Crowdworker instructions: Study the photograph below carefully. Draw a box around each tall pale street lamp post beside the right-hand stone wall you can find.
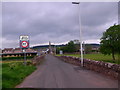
[72,2,83,67]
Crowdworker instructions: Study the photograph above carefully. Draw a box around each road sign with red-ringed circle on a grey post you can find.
[20,35,29,65]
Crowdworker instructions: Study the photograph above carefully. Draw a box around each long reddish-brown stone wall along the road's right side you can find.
[56,56,120,79]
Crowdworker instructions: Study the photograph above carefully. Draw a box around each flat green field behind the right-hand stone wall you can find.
[57,54,120,64]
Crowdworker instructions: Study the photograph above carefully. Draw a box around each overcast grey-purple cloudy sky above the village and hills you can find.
[2,2,118,48]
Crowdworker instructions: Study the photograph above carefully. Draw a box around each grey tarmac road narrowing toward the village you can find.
[17,55,118,88]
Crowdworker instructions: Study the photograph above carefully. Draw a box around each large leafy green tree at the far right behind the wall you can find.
[100,25,120,61]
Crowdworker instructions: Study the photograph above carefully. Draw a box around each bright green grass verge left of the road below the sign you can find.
[2,62,36,88]
